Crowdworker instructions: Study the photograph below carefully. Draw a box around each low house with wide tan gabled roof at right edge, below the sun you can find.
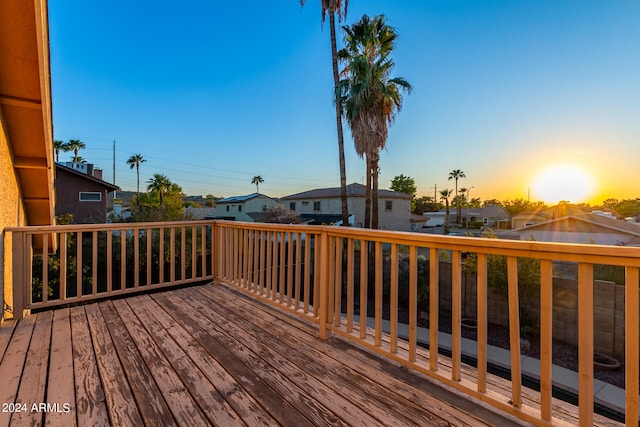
[513,213,640,246]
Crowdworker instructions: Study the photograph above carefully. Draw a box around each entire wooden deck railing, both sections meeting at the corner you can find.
[10,221,640,426]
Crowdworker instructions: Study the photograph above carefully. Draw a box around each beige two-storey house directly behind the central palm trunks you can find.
[280,183,412,231]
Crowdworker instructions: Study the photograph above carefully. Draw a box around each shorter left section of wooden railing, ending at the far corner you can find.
[6,221,215,317]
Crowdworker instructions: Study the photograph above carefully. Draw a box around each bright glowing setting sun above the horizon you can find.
[532,165,595,203]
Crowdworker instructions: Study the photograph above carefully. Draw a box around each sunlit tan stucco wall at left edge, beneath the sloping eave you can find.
[0,106,25,319]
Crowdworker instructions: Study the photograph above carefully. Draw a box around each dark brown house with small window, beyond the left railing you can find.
[56,163,118,224]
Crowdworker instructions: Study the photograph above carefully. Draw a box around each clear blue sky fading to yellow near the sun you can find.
[49,0,640,202]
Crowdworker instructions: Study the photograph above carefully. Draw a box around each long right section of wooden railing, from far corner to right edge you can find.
[216,222,640,426]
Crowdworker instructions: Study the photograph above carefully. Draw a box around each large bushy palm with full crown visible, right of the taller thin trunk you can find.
[338,15,412,228]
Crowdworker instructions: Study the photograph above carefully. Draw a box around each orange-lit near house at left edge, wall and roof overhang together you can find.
[0,0,55,322]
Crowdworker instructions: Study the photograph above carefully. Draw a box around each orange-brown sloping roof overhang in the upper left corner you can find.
[0,0,55,225]
